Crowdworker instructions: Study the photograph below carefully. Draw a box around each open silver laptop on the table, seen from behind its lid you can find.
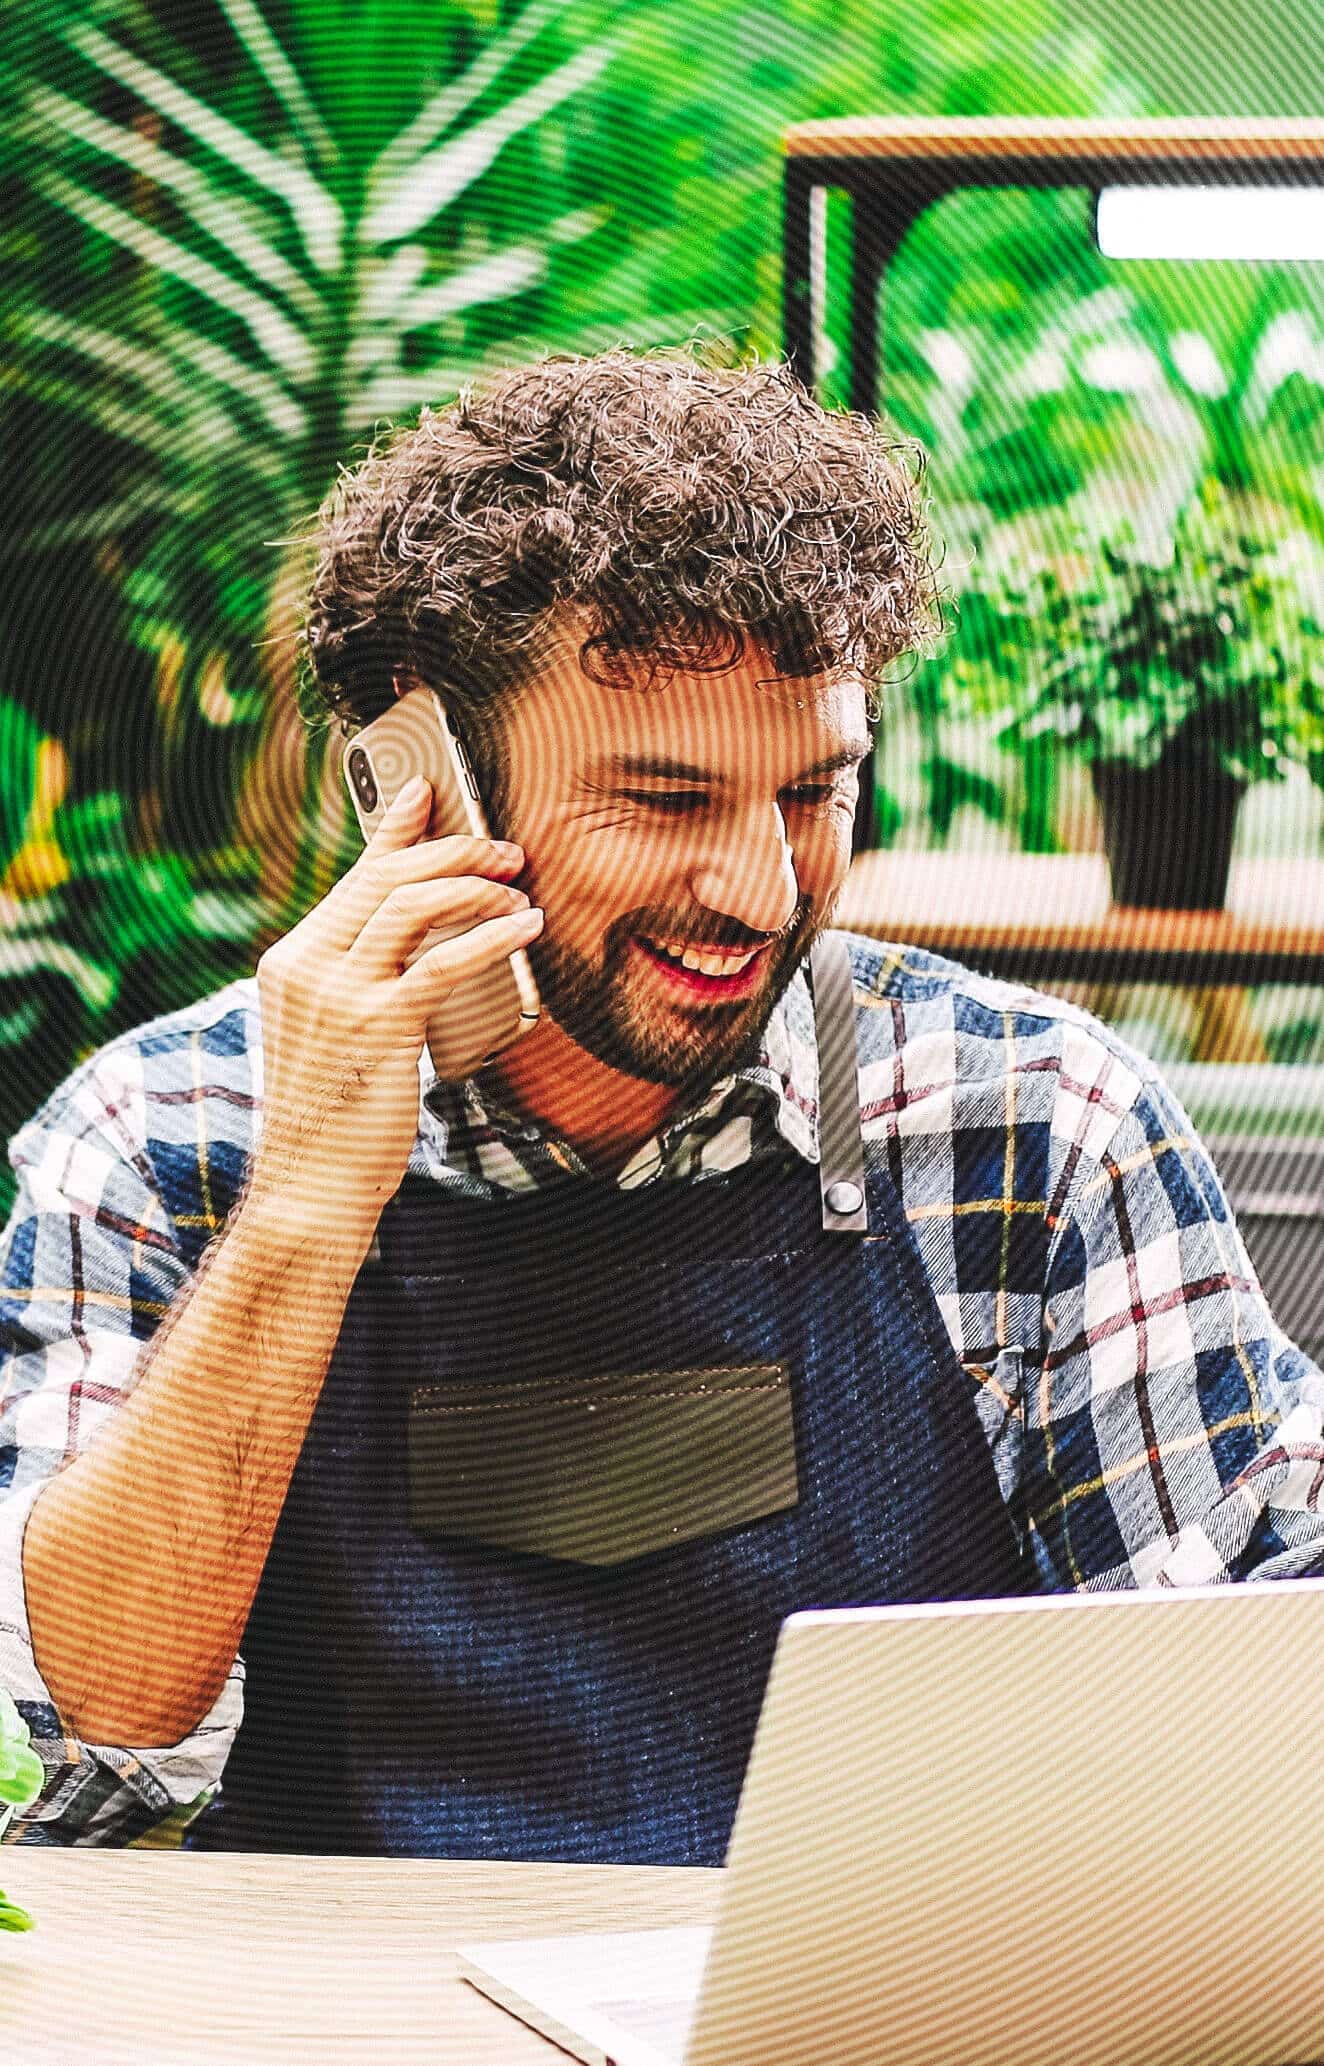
[461,1578,1324,2066]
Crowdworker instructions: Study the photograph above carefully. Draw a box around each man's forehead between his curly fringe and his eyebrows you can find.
[521,638,870,771]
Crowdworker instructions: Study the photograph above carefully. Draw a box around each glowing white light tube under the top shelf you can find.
[1099,186,1324,260]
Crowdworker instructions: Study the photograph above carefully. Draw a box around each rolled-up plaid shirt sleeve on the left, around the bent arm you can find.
[0,1045,244,1845]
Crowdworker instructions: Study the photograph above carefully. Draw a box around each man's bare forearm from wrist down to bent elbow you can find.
[23,1194,372,1748]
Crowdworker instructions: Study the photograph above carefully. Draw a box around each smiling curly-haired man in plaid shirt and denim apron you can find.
[0,353,1324,1864]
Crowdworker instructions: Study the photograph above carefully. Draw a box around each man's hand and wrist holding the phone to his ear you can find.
[248,779,543,1233]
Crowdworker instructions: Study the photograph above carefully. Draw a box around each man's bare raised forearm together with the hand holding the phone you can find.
[20,783,541,1768]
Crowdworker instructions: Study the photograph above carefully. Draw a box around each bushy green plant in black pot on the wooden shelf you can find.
[963,481,1324,911]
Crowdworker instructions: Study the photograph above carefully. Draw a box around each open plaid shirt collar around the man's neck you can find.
[419,967,818,1178]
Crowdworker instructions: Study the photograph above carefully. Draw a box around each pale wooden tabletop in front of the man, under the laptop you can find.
[0,1845,721,2066]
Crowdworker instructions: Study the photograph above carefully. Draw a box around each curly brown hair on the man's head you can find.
[302,349,942,729]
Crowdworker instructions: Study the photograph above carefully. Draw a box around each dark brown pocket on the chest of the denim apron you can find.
[409,1364,799,1566]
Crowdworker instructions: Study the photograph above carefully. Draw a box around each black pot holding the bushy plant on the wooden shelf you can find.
[1091,727,1246,911]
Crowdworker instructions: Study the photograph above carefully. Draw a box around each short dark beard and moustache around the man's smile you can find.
[529,897,830,1097]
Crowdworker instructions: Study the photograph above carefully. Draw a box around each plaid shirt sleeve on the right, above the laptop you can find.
[1024,1076,1324,1589]
